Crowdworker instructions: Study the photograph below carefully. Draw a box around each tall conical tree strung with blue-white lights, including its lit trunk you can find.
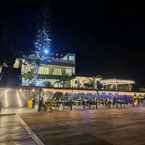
[23,7,51,86]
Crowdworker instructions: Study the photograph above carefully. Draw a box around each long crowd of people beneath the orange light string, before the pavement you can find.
[33,94,145,111]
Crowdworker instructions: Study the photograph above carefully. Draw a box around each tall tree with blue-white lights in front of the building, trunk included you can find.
[24,13,51,86]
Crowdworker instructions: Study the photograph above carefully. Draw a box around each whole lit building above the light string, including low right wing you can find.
[10,53,135,91]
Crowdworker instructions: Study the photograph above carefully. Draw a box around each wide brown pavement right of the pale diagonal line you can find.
[21,108,145,145]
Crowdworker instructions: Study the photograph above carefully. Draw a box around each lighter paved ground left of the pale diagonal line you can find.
[0,115,36,145]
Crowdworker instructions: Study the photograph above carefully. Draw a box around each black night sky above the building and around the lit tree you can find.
[0,0,145,85]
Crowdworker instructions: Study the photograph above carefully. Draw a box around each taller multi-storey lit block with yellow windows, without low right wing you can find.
[14,53,75,88]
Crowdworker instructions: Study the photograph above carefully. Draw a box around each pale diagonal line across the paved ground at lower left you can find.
[16,114,45,145]
